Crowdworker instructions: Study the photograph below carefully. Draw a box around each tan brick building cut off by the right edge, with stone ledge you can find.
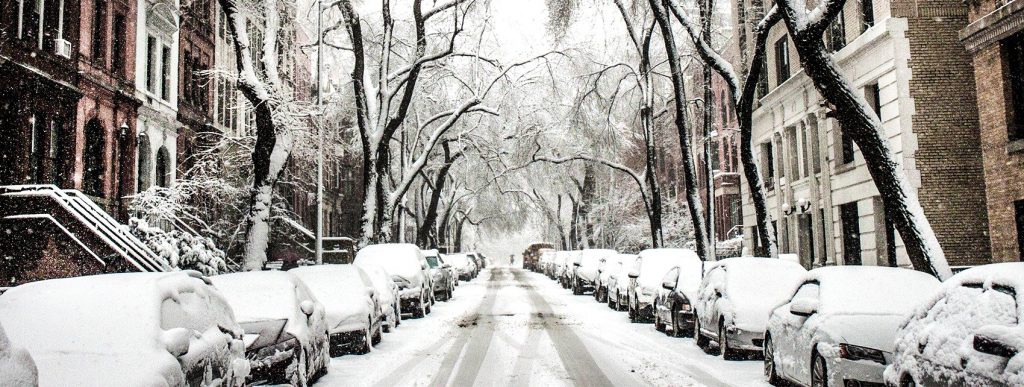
[959,0,1024,262]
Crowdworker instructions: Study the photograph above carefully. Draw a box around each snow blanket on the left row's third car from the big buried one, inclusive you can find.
[288,264,376,332]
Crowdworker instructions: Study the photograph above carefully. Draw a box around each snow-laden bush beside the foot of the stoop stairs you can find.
[129,218,227,275]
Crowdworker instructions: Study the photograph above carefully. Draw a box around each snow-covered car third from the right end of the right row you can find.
[693,257,807,359]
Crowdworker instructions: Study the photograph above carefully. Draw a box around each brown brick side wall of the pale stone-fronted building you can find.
[905,0,990,265]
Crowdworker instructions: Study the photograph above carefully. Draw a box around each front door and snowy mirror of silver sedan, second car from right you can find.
[774,281,821,385]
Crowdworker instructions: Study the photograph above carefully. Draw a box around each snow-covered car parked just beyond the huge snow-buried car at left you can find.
[210,270,331,386]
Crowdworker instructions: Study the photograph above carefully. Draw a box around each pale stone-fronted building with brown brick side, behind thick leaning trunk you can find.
[733,0,990,266]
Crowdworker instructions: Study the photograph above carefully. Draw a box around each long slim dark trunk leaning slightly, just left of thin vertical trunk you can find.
[649,0,709,260]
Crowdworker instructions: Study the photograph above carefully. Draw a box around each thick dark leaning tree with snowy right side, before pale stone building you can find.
[775,0,952,280]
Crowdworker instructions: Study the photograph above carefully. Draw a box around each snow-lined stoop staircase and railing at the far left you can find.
[0,184,172,271]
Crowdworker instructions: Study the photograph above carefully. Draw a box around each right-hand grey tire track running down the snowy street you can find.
[512,269,612,387]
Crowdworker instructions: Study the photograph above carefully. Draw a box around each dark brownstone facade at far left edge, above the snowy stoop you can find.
[0,0,82,187]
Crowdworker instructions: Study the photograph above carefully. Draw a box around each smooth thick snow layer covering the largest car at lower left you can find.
[0,271,241,386]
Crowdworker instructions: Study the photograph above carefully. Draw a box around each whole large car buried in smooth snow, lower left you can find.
[0,271,249,386]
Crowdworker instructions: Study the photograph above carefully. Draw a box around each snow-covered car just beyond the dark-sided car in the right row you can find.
[626,249,699,321]
